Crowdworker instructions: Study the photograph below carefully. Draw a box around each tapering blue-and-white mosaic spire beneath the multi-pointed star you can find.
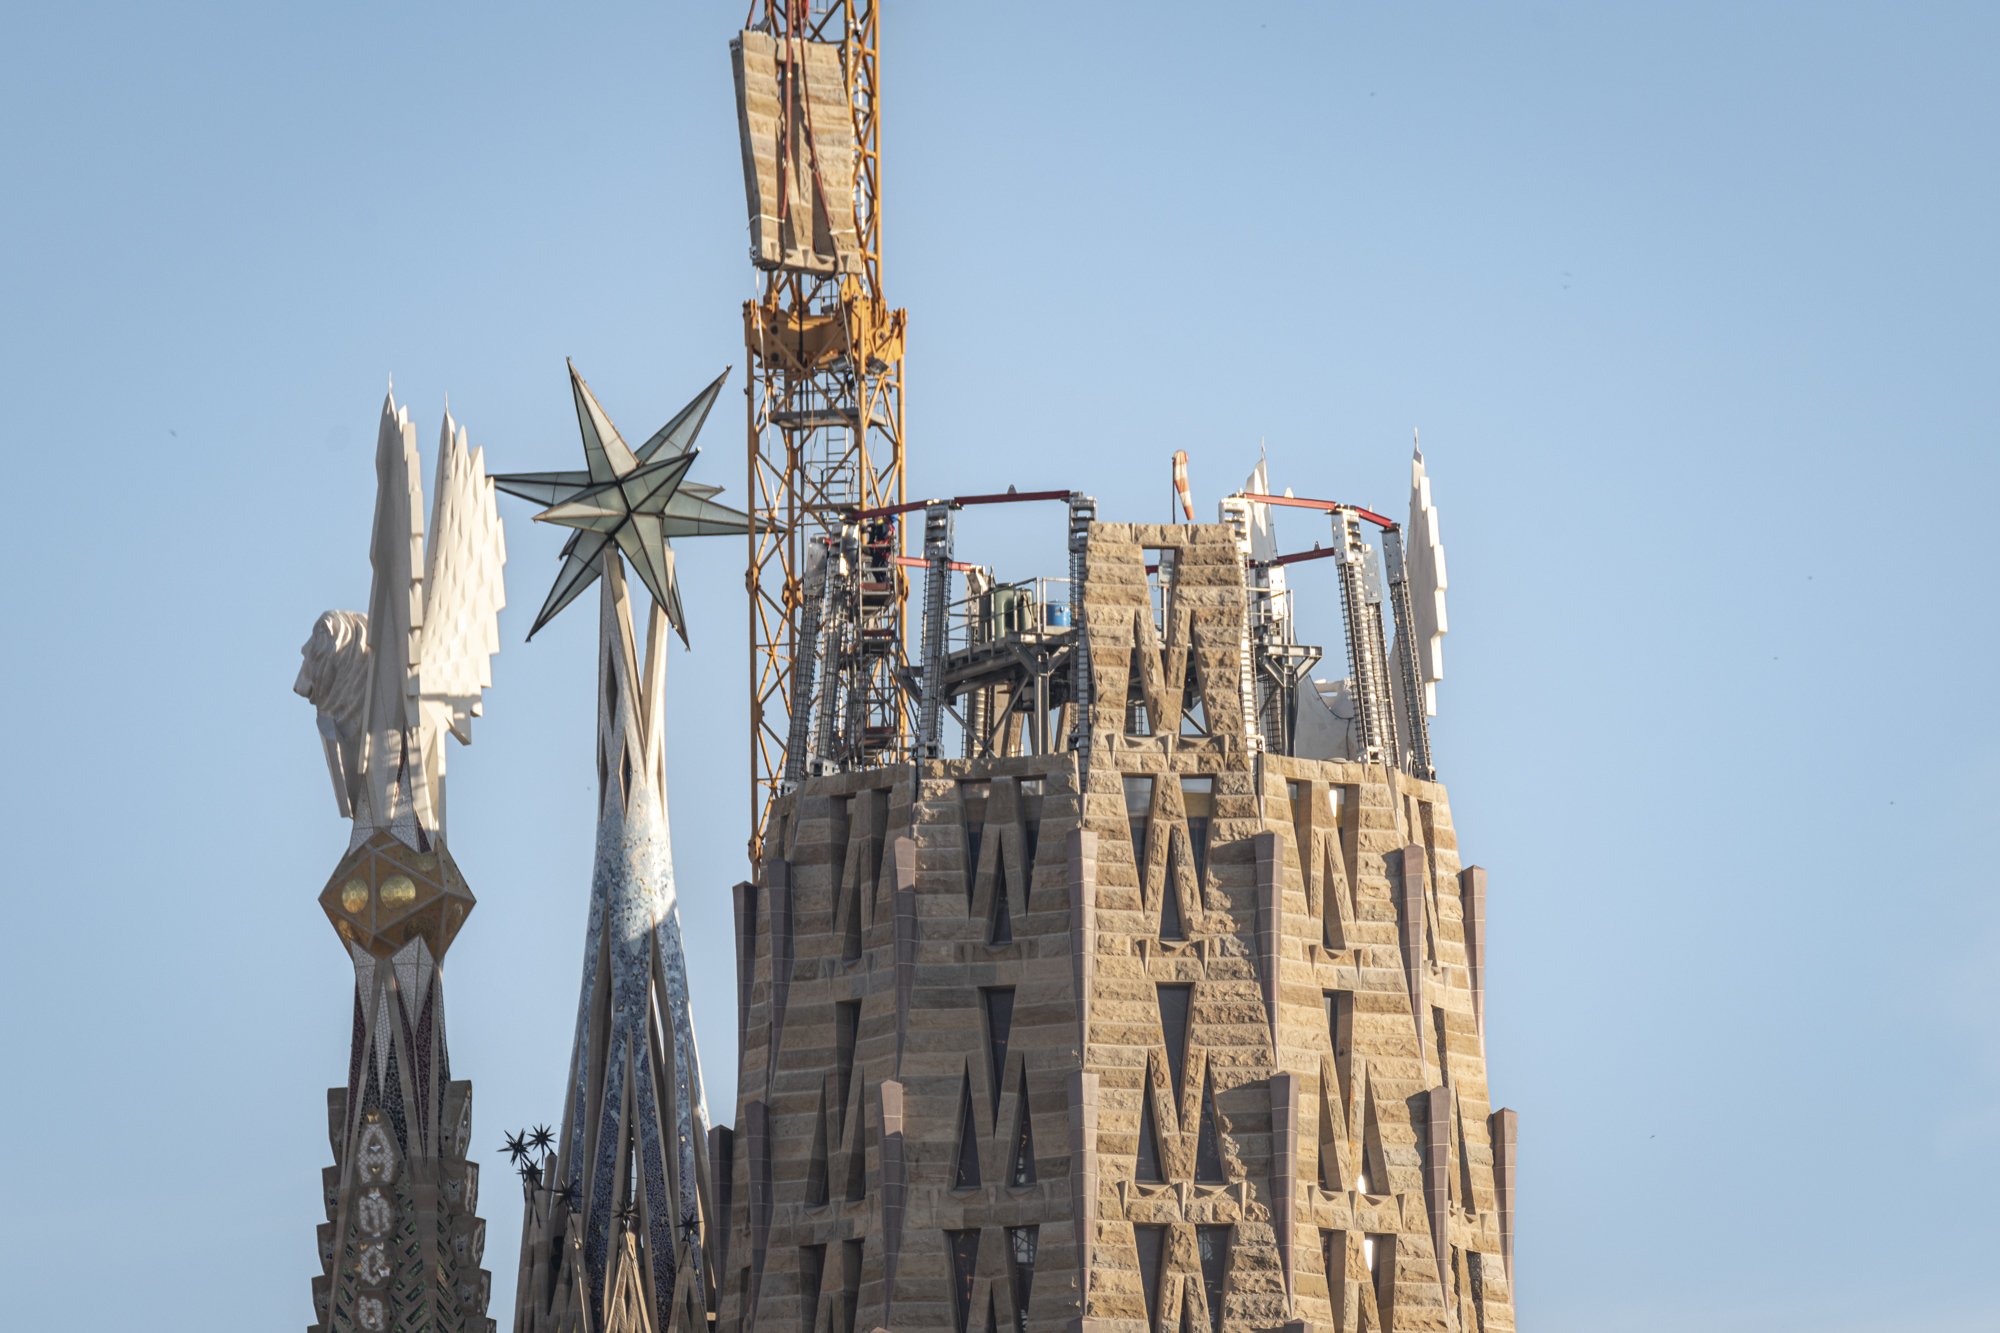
[514,552,710,1333]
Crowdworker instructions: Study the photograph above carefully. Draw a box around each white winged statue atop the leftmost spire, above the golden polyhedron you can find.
[292,390,506,849]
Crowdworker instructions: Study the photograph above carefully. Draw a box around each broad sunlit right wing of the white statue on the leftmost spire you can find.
[420,412,506,740]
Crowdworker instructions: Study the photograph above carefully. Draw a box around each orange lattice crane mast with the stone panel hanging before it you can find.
[732,0,910,863]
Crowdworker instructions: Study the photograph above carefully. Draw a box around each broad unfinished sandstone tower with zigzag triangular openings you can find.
[706,524,1514,1333]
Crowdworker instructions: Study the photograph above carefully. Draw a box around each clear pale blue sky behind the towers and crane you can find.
[0,0,2000,1333]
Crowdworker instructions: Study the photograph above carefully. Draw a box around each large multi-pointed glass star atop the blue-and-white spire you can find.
[492,364,750,642]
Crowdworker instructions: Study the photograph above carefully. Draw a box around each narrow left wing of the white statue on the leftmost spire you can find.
[362,394,424,825]
